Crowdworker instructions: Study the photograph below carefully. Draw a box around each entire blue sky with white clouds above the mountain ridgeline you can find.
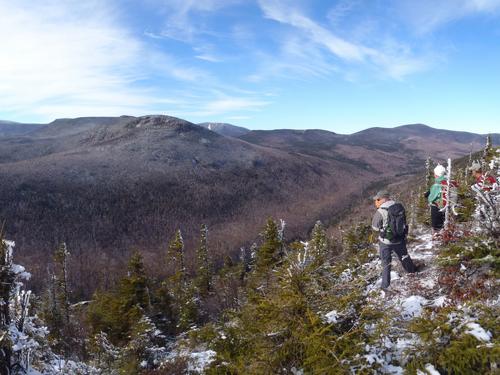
[0,0,500,133]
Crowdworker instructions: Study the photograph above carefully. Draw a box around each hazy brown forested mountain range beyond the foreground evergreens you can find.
[0,115,500,291]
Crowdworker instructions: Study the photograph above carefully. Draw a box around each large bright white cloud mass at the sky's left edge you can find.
[0,0,213,120]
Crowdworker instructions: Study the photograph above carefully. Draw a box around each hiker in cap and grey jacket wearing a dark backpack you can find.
[372,190,416,289]
